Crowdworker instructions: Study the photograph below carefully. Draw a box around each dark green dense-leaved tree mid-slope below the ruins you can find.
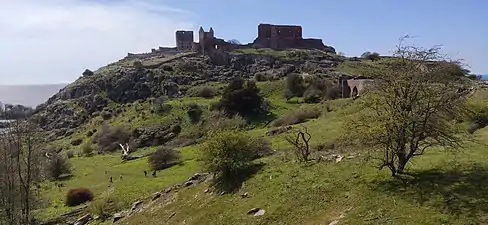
[217,78,263,117]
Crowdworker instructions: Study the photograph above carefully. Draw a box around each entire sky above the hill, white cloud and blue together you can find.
[0,0,488,85]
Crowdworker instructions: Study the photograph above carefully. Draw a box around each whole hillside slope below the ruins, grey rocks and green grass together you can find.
[31,49,488,225]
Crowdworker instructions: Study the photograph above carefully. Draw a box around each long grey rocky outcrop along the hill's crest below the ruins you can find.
[34,49,339,142]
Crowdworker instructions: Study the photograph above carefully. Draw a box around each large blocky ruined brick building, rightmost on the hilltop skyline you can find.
[253,24,335,53]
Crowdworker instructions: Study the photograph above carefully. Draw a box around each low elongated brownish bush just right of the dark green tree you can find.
[270,107,322,127]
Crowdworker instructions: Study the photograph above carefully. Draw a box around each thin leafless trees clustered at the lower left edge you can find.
[0,120,43,225]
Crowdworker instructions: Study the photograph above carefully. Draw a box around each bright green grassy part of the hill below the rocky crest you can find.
[30,50,488,225]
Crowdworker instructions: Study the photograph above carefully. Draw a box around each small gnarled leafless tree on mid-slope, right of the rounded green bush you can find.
[285,126,312,162]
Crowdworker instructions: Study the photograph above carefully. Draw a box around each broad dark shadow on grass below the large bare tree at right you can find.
[373,165,488,220]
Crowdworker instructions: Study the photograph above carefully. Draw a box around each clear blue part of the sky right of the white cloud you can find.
[170,0,488,73]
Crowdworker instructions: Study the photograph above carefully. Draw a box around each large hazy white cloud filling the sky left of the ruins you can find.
[0,0,195,84]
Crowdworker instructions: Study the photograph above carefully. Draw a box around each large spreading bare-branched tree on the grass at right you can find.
[345,36,469,176]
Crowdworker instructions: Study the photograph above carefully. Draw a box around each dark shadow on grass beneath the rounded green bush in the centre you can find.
[213,163,265,193]
